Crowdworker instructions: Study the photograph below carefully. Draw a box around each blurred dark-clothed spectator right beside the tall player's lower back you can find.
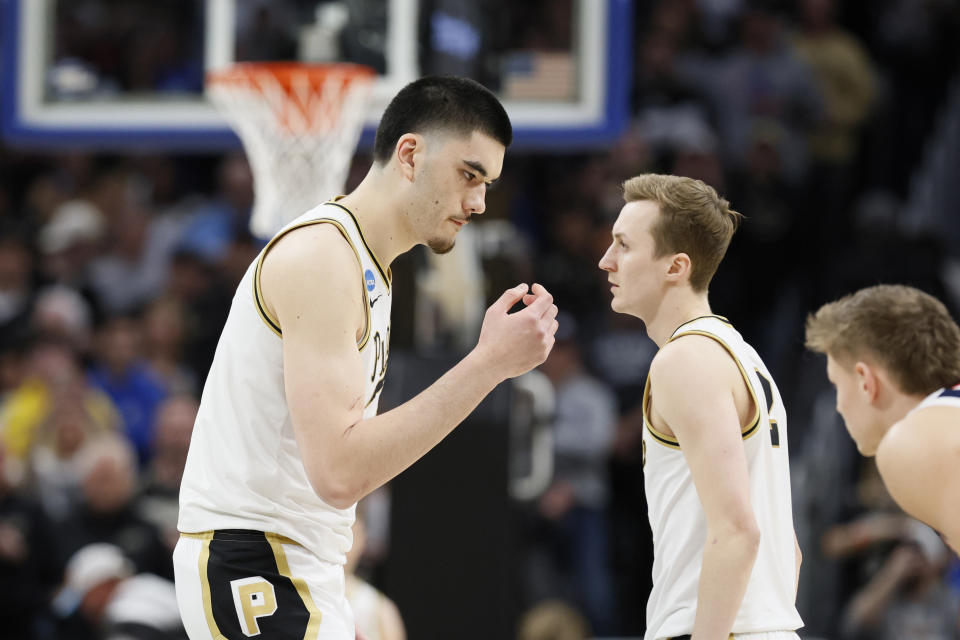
[138,394,199,554]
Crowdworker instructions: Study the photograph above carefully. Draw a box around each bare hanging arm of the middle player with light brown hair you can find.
[650,336,760,640]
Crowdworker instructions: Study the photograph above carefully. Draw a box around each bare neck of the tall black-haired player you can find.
[340,166,416,267]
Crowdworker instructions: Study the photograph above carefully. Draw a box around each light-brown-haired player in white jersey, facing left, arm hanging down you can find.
[600,174,802,640]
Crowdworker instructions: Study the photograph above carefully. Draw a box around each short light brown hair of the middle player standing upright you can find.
[623,173,743,292]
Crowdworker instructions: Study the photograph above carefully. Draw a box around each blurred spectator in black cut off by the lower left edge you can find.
[0,444,63,640]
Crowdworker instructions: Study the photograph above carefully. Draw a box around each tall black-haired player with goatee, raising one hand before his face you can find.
[174,77,557,640]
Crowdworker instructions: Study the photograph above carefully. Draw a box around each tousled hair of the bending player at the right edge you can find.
[807,285,960,395]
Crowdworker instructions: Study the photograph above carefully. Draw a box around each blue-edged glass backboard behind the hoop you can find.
[0,0,632,151]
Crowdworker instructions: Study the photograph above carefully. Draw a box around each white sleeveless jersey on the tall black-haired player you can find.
[178,201,391,564]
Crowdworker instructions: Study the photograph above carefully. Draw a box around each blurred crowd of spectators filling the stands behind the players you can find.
[0,0,960,640]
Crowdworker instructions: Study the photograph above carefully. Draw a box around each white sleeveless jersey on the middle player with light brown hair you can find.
[643,316,803,640]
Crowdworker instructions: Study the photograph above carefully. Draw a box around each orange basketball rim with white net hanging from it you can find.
[207,62,375,238]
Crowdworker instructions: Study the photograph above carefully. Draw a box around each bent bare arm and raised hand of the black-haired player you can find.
[261,224,557,508]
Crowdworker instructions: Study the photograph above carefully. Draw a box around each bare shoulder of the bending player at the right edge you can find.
[877,407,960,553]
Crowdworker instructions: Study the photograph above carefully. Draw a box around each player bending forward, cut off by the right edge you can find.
[807,285,960,552]
